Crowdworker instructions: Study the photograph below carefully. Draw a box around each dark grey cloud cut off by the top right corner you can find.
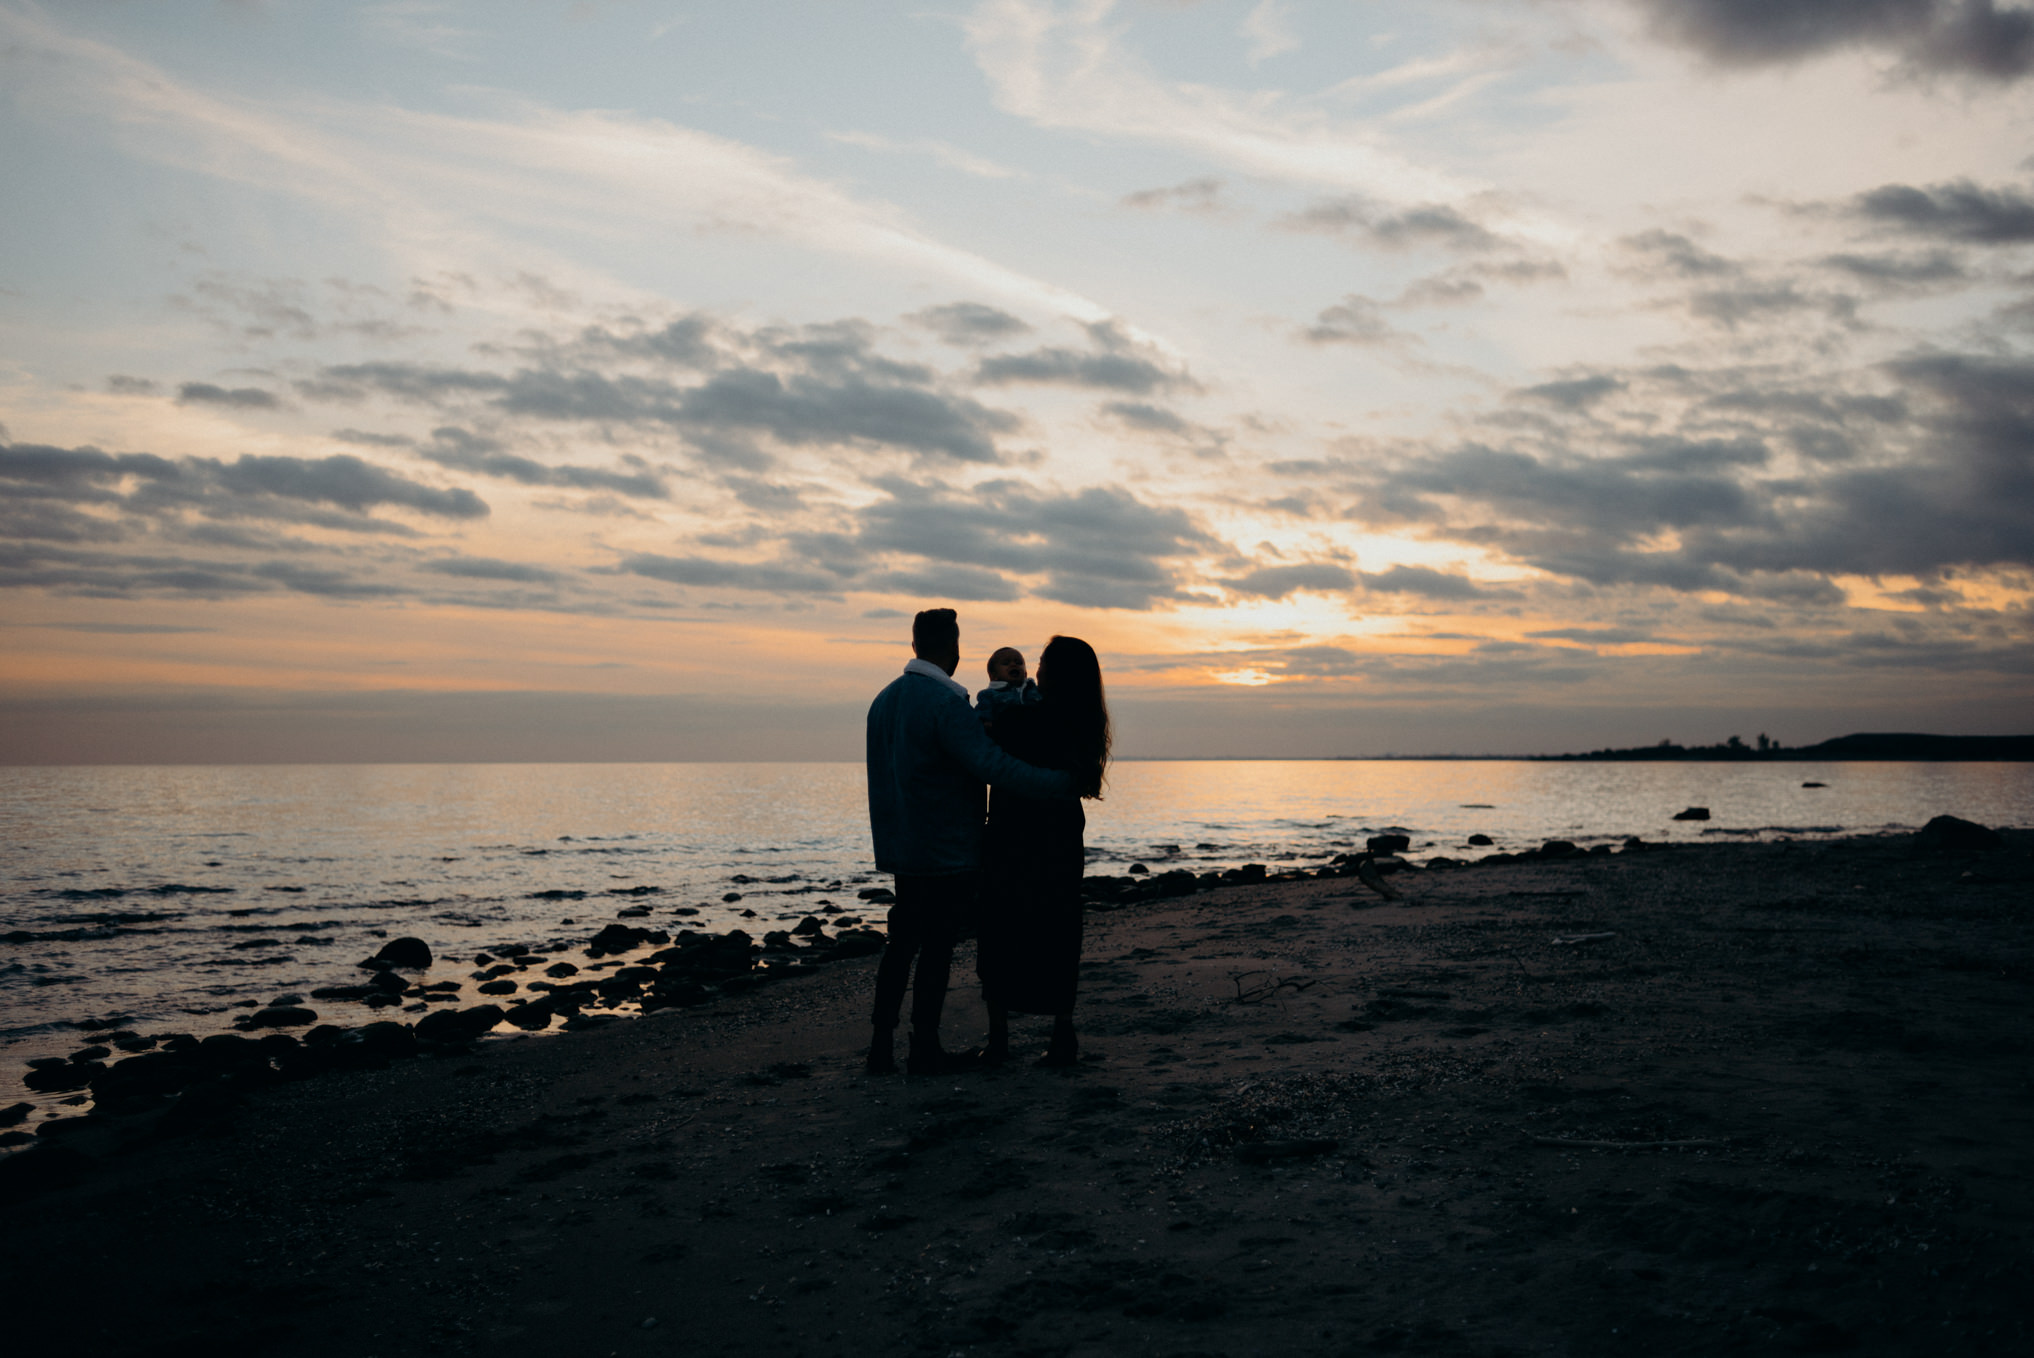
[1633,0,2034,81]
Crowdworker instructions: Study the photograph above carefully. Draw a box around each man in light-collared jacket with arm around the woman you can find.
[869,608,1076,1075]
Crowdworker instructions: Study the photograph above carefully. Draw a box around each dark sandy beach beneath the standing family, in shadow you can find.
[0,834,2034,1358]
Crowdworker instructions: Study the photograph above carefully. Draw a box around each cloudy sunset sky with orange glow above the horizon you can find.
[0,0,2034,762]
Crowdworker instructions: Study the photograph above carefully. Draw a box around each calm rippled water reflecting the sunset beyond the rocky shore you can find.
[0,760,2034,1102]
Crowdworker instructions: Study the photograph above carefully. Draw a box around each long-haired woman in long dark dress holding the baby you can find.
[974,636,1109,1065]
